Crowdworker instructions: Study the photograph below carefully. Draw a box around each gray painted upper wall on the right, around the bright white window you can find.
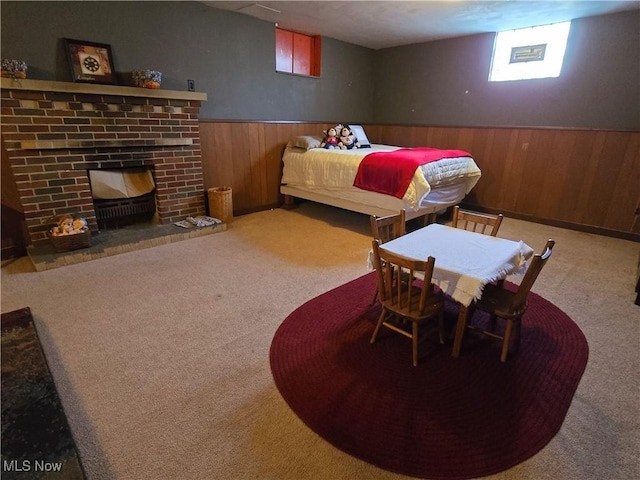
[374,11,640,130]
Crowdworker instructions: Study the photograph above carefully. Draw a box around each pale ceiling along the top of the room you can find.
[201,0,640,50]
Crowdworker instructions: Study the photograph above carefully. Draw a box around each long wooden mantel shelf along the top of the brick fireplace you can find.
[1,78,207,101]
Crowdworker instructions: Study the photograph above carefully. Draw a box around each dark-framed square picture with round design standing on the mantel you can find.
[64,38,116,84]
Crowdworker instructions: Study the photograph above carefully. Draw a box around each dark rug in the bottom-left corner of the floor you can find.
[1,308,85,480]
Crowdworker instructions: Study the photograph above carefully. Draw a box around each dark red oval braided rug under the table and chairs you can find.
[270,273,588,479]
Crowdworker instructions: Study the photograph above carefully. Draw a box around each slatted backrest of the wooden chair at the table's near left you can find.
[372,240,436,316]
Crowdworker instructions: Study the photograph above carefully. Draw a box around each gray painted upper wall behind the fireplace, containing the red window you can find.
[1,1,375,123]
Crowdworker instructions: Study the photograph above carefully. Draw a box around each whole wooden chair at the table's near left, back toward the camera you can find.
[371,240,444,367]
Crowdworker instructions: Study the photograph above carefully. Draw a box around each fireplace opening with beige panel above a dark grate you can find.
[89,168,156,229]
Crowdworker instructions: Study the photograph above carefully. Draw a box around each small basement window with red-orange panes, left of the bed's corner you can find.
[276,28,321,77]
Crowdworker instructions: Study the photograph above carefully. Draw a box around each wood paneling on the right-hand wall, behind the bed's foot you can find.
[368,126,640,236]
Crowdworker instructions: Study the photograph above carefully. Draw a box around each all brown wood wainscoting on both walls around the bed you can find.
[200,120,640,240]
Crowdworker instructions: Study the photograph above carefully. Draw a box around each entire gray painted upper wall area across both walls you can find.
[0,0,640,130]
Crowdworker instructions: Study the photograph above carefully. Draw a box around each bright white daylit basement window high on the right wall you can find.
[489,22,571,82]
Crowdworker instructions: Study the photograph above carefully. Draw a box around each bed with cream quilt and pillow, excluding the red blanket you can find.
[280,130,481,219]
